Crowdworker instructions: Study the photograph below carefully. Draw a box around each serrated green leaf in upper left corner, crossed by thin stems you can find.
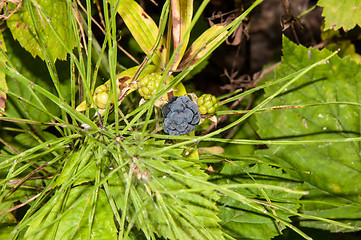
[6,0,75,62]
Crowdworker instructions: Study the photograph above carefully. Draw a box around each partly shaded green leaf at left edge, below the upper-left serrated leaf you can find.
[0,31,70,122]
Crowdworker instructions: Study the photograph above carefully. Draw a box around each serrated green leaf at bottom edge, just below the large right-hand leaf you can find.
[215,161,302,239]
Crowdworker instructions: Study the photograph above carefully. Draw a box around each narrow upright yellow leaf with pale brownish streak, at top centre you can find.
[171,0,193,71]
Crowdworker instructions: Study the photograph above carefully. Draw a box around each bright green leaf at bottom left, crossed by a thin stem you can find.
[25,186,117,240]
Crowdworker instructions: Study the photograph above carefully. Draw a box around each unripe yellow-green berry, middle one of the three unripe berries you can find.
[138,73,162,100]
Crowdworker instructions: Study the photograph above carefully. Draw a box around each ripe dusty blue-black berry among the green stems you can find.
[162,96,200,136]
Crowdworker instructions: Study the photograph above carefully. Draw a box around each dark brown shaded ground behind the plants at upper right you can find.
[194,0,322,95]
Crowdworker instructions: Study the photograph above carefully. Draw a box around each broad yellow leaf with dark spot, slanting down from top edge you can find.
[110,0,166,66]
